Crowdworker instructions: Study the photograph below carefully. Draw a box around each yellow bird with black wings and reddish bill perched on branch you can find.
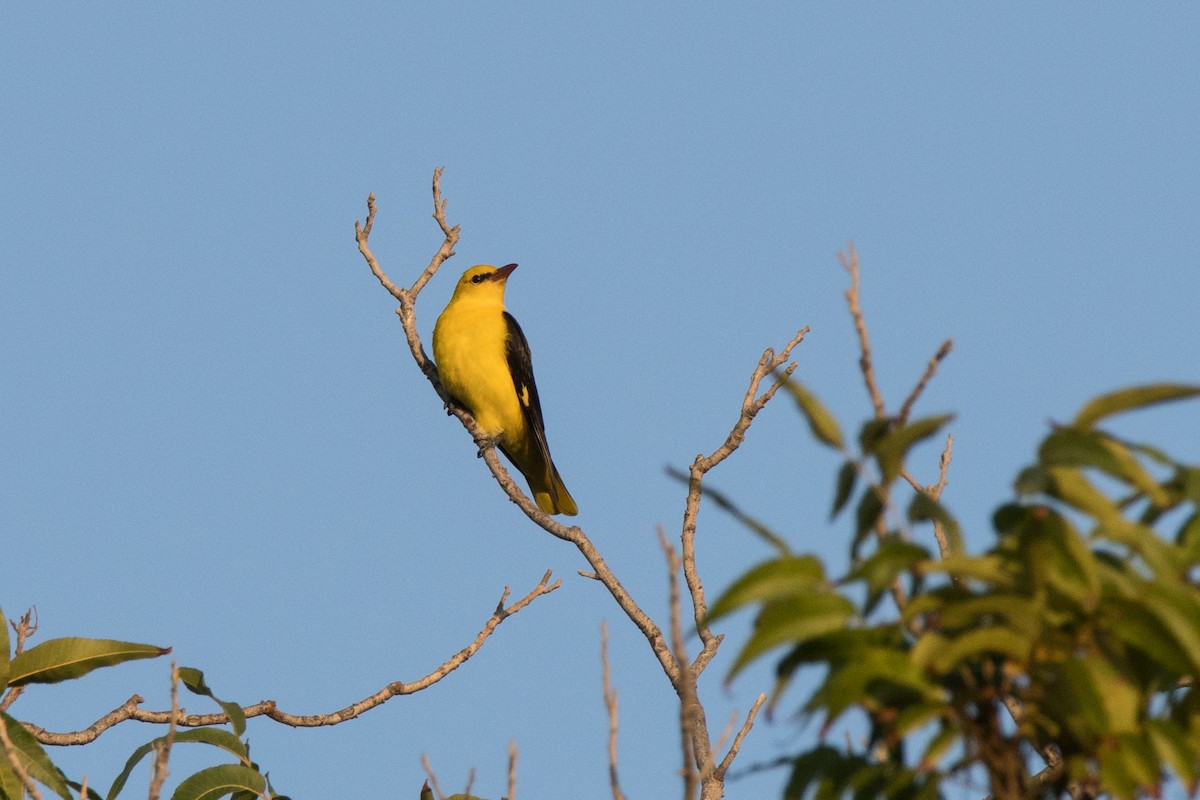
[433,264,578,516]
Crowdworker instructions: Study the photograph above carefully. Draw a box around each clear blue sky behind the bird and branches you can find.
[0,2,1200,799]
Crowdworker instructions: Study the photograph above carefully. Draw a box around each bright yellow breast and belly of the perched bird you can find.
[433,292,526,440]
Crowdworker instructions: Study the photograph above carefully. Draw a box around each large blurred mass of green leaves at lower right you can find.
[713,385,1200,800]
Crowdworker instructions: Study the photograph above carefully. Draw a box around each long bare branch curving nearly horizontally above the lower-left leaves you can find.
[24,570,563,745]
